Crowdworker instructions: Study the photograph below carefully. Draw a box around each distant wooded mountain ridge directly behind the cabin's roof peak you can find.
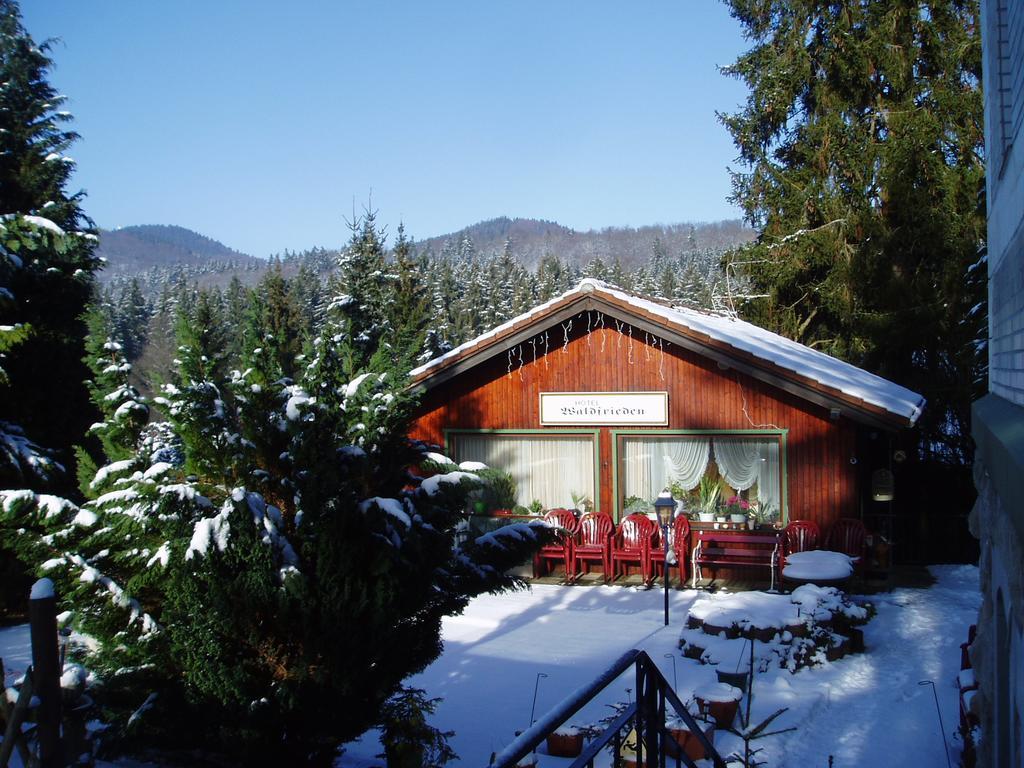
[416,216,755,267]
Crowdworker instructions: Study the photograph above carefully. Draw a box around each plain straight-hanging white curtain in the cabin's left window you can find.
[453,434,596,509]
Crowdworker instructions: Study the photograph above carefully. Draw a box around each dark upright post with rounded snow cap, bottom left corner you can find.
[29,579,61,768]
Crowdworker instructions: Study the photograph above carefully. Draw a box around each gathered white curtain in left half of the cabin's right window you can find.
[623,437,711,502]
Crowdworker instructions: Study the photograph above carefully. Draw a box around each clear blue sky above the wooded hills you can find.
[22,0,745,256]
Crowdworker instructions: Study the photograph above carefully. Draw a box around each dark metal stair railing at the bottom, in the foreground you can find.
[489,648,726,768]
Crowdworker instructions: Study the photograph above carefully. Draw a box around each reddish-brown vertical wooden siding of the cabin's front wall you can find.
[412,316,857,526]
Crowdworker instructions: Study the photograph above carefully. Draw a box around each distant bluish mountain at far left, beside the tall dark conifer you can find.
[97,224,266,282]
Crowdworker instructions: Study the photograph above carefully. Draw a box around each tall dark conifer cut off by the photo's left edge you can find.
[0,0,98,492]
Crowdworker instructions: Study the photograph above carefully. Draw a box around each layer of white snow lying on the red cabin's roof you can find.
[410,278,925,426]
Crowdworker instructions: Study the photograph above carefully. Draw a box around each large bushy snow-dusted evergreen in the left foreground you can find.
[0,293,548,764]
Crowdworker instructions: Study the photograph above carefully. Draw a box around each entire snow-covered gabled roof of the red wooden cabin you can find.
[411,279,925,425]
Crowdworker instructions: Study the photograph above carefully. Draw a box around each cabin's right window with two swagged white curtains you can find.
[618,432,785,519]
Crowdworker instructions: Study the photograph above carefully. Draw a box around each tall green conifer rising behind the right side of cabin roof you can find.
[722,0,985,463]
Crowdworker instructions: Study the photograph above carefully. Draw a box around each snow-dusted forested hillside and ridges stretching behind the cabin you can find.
[101,213,752,397]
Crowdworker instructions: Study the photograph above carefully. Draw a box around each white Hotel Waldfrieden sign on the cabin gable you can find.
[541,392,669,427]
